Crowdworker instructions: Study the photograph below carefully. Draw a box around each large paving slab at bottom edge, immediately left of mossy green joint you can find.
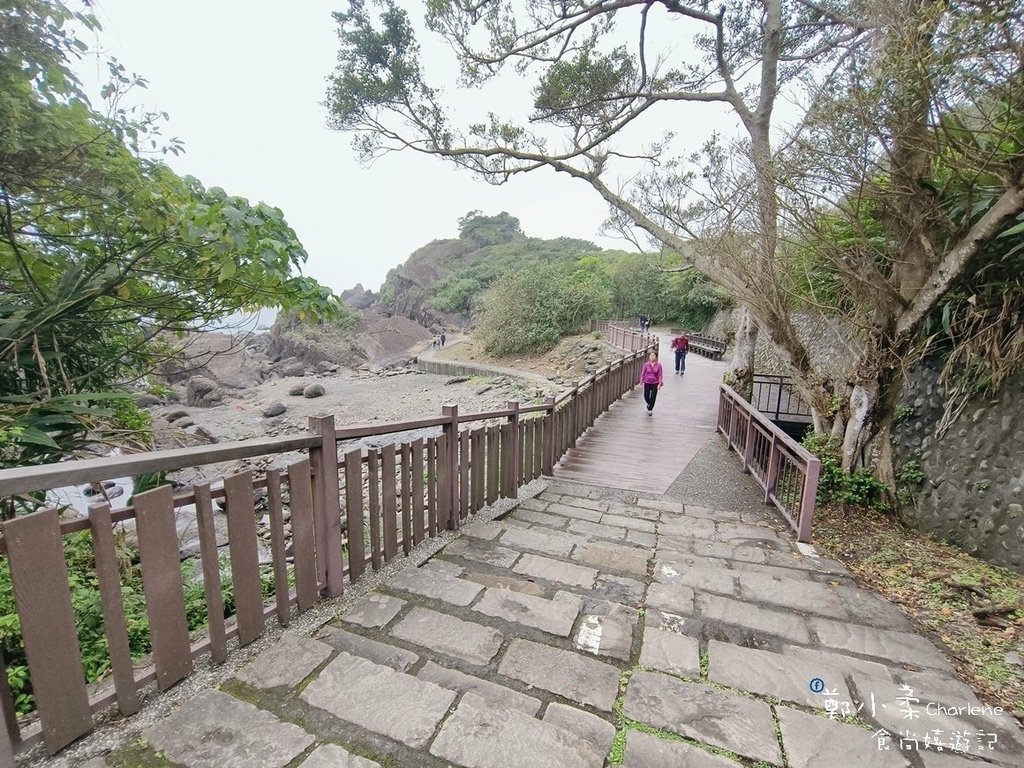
[430,693,604,768]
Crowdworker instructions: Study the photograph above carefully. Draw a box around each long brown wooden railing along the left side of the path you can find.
[0,348,648,763]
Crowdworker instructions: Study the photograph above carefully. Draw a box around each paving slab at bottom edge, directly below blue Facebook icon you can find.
[775,707,910,768]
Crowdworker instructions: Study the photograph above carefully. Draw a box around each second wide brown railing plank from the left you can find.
[134,485,193,690]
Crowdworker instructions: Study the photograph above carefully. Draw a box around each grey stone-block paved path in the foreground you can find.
[105,484,1024,768]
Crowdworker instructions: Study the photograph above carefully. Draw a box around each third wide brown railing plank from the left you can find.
[224,472,265,646]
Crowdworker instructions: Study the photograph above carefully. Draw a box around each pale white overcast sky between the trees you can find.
[78,0,734,291]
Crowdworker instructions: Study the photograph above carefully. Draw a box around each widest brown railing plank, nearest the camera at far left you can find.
[3,509,91,755]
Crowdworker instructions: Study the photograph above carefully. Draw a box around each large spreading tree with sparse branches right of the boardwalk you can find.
[328,0,1024,501]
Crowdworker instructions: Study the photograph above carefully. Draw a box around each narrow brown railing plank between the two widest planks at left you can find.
[89,504,138,717]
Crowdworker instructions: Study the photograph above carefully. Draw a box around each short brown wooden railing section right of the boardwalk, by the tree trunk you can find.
[718,384,821,542]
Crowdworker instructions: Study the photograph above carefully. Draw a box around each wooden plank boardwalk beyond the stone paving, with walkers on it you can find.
[555,334,727,494]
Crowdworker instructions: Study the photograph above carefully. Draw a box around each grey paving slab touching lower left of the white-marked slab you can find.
[498,639,618,712]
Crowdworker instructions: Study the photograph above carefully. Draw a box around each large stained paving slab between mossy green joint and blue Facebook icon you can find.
[623,671,782,765]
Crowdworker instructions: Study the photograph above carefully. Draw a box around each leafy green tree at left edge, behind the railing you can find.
[0,0,340,475]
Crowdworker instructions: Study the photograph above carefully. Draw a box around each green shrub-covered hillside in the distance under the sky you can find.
[381,211,728,354]
